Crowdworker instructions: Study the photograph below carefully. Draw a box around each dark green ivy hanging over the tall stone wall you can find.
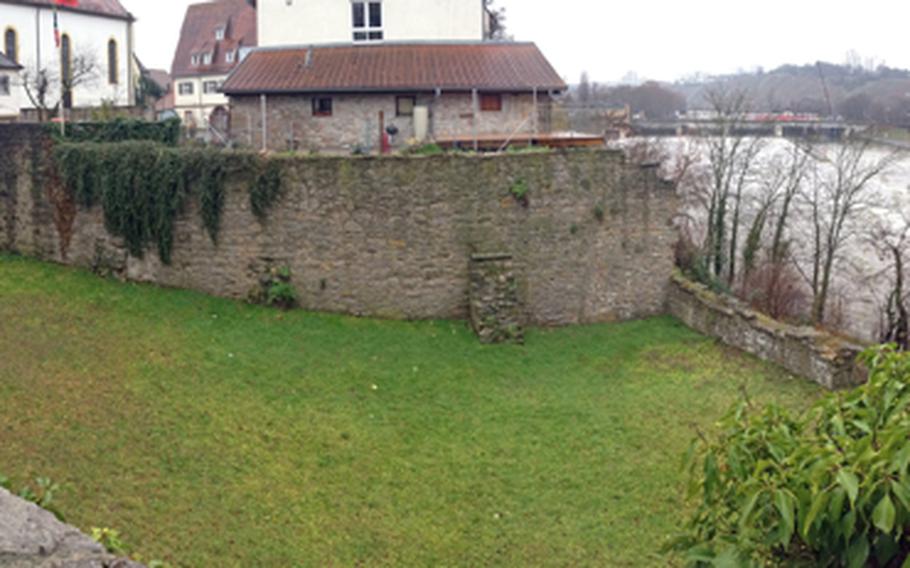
[53,141,284,264]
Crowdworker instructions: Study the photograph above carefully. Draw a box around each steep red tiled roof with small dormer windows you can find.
[171,0,256,77]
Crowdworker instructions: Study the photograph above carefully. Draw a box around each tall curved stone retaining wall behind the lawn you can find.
[0,126,677,325]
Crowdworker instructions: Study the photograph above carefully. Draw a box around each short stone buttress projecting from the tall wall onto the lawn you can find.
[469,254,524,343]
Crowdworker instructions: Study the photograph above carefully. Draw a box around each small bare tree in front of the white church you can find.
[20,48,100,122]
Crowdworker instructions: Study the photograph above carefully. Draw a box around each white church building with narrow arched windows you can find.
[0,0,135,118]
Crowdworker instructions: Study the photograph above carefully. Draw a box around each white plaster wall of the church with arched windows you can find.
[0,2,133,112]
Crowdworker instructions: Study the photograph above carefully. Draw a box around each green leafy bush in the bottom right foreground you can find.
[674,347,910,568]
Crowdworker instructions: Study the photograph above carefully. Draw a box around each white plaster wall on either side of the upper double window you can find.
[257,0,484,47]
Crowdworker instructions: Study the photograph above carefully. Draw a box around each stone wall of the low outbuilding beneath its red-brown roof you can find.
[231,93,550,153]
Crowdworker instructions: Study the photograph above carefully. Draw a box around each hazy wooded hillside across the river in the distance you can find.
[668,63,910,126]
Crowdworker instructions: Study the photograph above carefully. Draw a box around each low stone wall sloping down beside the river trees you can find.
[668,273,866,389]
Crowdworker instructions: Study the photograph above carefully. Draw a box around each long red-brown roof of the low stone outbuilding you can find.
[223,42,566,95]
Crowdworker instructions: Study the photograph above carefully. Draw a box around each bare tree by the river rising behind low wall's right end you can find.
[803,140,899,324]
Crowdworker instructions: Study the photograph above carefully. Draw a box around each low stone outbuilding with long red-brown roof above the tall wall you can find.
[223,42,566,151]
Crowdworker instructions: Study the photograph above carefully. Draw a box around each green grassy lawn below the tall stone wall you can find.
[0,256,818,566]
